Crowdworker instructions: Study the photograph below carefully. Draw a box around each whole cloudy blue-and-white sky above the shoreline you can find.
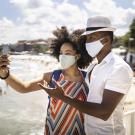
[0,0,135,44]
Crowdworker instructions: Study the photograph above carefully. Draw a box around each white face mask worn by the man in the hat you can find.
[85,38,104,57]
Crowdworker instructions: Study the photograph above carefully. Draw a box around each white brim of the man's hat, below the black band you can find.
[81,27,116,36]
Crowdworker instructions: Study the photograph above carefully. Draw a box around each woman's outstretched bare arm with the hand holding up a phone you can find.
[0,56,52,93]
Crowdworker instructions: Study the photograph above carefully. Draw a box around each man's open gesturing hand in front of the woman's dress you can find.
[38,80,65,99]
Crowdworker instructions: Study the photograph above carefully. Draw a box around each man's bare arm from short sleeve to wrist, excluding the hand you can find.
[61,90,124,120]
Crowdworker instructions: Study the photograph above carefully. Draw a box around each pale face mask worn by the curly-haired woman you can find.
[59,54,76,69]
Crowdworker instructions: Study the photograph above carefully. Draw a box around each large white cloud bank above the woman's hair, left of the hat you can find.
[1,0,87,42]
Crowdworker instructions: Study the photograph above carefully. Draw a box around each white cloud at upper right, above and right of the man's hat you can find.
[84,0,135,35]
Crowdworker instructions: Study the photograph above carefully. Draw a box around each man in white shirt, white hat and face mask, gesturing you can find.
[39,16,133,135]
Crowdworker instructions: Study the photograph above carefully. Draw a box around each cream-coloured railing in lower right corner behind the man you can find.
[124,109,135,135]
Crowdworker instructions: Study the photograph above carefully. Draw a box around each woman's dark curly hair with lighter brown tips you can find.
[50,26,92,68]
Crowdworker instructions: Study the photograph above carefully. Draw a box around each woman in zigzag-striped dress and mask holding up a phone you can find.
[0,27,90,135]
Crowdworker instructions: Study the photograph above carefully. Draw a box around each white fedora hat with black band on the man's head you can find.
[82,16,116,35]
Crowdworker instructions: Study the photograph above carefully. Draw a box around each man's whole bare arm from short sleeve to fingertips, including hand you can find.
[39,83,124,120]
